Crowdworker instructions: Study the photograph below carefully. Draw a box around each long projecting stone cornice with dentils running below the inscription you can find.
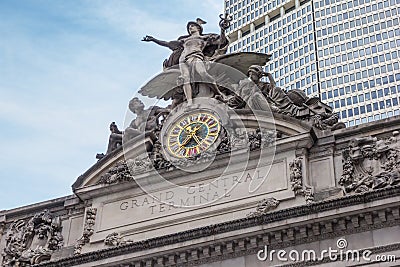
[36,186,400,267]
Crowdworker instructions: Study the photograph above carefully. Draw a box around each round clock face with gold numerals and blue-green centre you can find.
[167,112,221,158]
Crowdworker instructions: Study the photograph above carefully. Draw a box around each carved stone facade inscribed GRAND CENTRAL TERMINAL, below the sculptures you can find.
[0,114,400,267]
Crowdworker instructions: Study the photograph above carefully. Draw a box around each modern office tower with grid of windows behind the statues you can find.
[225,0,400,126]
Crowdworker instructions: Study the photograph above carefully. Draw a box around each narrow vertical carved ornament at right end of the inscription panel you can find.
[289,157,314,203]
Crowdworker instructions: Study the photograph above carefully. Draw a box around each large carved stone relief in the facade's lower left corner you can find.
[2,210,63,267]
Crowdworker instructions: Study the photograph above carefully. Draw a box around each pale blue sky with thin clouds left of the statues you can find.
[0,0,223,210]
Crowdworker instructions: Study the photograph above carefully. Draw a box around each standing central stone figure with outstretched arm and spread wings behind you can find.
[139,15,270,106]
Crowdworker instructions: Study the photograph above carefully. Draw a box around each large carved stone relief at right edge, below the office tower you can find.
[339,131,400,193]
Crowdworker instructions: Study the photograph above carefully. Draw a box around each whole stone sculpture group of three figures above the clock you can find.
[99,15,344,158]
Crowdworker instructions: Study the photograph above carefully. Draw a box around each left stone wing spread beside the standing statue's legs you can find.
[139,68,181,100]
